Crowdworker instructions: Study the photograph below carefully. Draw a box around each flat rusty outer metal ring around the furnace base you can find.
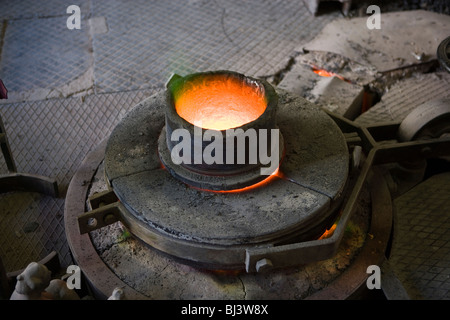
[64,140,392,300]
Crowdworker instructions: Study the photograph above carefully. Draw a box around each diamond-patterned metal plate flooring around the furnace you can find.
[0,0,450,299]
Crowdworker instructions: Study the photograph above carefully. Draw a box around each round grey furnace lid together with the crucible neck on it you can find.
[76,71,349,270]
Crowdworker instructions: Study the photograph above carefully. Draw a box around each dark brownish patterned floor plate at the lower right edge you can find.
[390,173,450,300]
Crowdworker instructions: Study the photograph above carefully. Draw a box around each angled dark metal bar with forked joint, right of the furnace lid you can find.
[245,110,450,272]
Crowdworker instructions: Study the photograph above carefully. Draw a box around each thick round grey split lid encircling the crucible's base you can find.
[105,91,349,268]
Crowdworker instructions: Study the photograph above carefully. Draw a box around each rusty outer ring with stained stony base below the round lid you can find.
[64,149,392,300]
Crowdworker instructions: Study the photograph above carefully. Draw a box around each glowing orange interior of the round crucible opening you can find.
[175,77,267,130]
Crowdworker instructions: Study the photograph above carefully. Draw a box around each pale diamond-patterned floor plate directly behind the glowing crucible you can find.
[92,1,337,92]
